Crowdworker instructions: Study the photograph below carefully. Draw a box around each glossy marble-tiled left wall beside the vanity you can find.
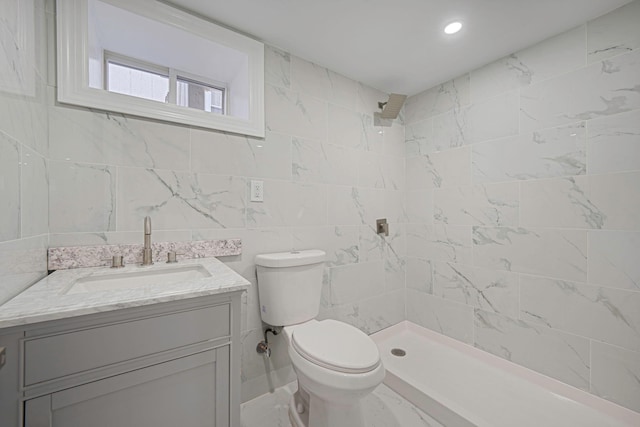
[0,0,49,304]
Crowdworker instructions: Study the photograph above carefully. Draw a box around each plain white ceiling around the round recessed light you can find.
[170,0,630,95]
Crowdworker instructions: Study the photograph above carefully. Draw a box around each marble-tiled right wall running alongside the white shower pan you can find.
[405,1,640,411]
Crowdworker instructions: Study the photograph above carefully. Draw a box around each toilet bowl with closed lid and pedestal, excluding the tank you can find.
[284,320,385,427]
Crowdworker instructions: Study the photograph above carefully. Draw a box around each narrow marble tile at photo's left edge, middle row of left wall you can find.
[0,132,20,241]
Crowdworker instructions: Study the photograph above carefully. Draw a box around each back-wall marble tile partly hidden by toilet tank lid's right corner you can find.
[291,226,360,267]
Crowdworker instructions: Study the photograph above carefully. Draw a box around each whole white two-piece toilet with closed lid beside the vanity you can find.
[255,250,385,427]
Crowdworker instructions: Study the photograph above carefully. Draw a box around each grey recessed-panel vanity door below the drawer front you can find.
[25,346,229,427]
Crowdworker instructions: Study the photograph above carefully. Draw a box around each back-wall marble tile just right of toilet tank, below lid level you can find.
[330,261,385,305]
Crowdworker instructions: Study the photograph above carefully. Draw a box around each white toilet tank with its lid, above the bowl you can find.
[255,249,325,326]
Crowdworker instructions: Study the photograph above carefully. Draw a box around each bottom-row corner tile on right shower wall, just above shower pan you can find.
[407,289,473,344]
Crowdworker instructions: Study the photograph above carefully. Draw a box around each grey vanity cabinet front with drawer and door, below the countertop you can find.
[0,292,241,427]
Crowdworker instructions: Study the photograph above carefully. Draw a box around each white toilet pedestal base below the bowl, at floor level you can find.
[289,389,365,427]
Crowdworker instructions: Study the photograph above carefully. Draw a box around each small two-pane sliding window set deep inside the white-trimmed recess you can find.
[104,52,227,114]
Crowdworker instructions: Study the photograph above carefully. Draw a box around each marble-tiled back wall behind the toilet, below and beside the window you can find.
[48,5,405,400]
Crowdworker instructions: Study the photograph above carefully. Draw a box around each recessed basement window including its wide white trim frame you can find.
[56,0,265,137]
